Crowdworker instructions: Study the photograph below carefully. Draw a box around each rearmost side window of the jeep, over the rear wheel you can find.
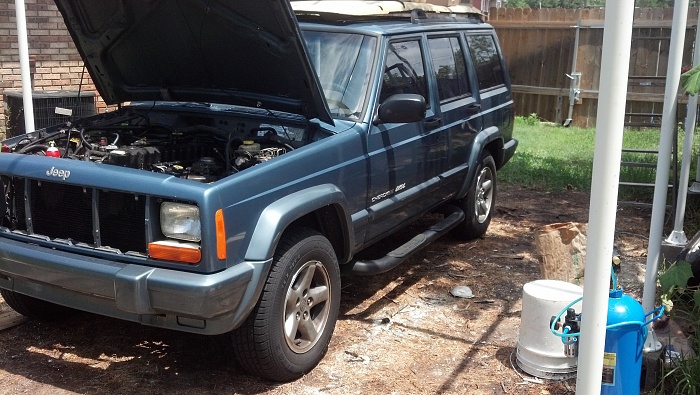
[466,35,505,90]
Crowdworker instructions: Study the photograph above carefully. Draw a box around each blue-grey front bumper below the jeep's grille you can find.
[0,238,271,335]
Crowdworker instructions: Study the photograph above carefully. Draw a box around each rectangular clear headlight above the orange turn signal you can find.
[160,202,202,242]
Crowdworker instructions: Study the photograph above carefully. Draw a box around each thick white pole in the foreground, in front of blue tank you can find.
[576,0,634,395]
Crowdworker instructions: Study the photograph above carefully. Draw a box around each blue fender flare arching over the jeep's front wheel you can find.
[245,184,354,263]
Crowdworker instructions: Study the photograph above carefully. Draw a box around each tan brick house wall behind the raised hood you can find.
[0,0,106,133]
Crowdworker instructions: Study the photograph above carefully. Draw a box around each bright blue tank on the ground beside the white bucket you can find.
[600,290,648,395]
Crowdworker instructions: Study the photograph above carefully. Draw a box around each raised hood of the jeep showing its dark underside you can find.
[56,0,333,123]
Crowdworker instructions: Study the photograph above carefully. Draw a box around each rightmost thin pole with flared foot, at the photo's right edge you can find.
[666,9,700,245]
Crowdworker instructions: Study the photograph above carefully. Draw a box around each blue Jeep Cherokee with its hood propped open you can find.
[0,0,517,381]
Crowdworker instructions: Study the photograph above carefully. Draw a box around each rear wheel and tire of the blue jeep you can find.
[452,152,497,240]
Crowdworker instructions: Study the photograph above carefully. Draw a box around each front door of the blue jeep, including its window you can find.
[367,37,447,240]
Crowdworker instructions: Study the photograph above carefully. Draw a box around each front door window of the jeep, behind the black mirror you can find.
[379,40,428,102]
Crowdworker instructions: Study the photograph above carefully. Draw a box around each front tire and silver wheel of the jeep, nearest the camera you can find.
[231,228,340,382]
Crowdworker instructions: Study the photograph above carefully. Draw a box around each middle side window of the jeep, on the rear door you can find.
[428,37,470,102]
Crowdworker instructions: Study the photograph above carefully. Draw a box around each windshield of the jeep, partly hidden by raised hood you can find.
[304,31,377,120]
